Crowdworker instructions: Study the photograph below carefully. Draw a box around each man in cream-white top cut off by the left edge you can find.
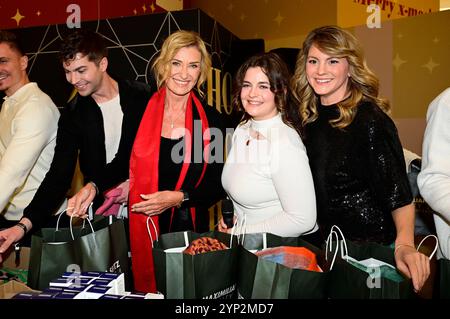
[0,31,59,235]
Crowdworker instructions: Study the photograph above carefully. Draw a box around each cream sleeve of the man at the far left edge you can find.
[0,101,57,211]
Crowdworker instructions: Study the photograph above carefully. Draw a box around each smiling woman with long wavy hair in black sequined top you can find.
[292,26,430,290]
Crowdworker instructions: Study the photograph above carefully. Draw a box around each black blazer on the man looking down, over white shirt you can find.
[23,80,151,229]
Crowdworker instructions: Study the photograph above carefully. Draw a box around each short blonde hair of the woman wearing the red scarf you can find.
[152,30,211,96]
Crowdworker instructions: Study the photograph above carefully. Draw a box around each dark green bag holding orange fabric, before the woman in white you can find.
[237,233,328,299]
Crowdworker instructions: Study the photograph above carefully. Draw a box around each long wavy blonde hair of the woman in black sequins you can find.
[292,26,390,129]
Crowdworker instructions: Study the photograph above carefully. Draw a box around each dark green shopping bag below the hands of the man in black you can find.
[28,217,129,290]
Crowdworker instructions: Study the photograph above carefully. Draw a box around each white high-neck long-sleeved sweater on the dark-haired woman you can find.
[222,115,317,237]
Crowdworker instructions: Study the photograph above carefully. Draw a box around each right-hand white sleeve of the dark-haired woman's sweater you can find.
[246,131,317,237]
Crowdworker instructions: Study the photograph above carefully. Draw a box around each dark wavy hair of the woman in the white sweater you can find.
[232,52,302,136]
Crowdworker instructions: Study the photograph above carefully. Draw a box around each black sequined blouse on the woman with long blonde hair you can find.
[305,102,413,244]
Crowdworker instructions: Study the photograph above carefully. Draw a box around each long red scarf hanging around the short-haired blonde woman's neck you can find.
[128,87,211,292]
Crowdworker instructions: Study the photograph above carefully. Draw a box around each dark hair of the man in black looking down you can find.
[59,29,108,64]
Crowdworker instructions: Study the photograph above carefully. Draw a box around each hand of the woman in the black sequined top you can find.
[394,245,430,292]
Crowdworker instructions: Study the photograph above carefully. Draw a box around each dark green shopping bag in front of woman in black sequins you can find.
[328,240,413,299]
